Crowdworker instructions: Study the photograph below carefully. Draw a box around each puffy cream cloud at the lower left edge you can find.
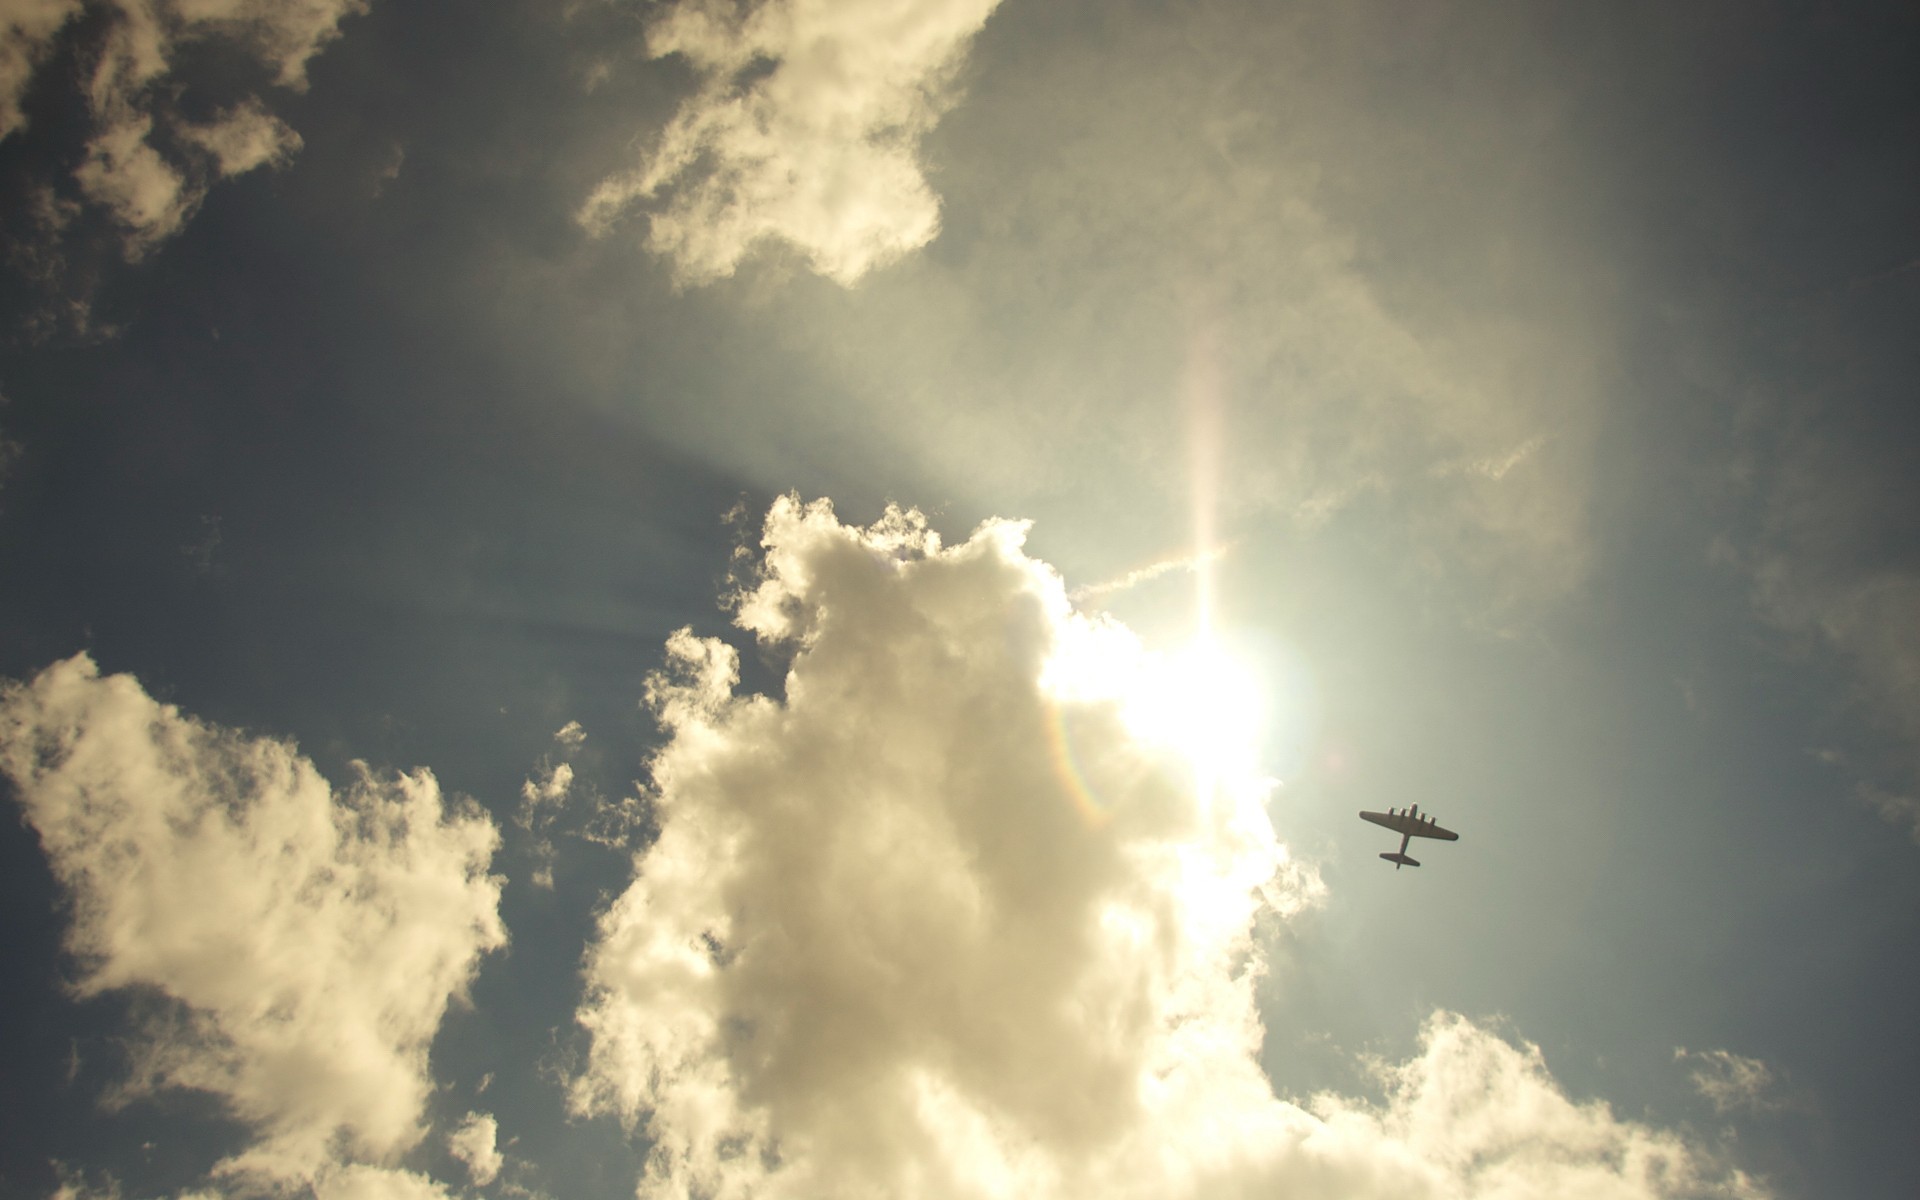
[0,655,505,1196]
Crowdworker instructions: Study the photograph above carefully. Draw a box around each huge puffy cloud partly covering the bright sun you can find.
[572,497,1764,1200]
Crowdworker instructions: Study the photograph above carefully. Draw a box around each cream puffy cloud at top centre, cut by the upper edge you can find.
[580,0,998,286]
